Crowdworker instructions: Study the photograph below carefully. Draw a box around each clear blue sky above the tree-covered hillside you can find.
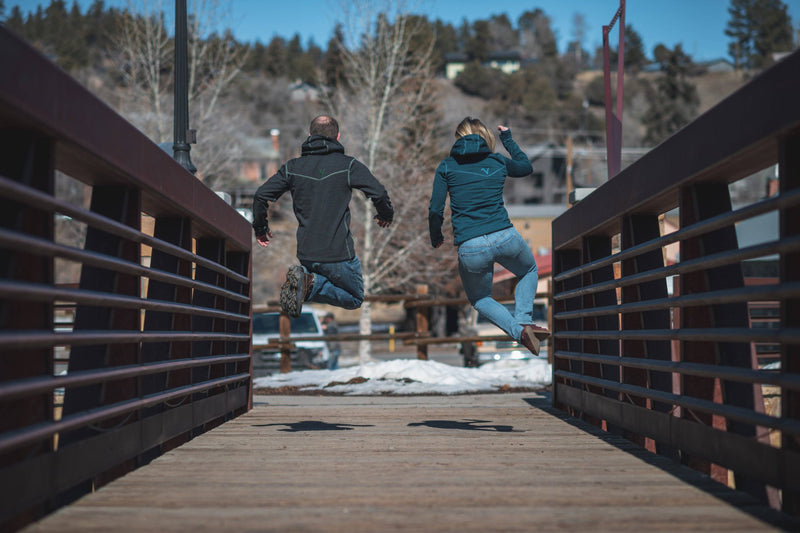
[6,0,800,61]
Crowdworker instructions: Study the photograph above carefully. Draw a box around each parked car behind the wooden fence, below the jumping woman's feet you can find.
[461,299,548,367]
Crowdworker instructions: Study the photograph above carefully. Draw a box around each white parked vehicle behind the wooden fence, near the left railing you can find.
[253,308,331,377]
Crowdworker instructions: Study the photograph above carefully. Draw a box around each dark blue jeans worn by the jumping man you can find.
[300,257,364,309]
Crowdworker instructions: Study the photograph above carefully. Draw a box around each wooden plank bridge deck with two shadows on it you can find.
[26,393,791,533]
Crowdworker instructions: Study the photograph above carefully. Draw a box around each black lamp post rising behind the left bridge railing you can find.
[172,0,197,174]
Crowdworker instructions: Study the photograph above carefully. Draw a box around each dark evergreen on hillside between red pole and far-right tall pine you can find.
[642,45,700,144]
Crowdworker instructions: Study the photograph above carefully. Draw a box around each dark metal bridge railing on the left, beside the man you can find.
[0,27,251,529]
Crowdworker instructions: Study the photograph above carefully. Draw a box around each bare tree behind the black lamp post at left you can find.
[113,0,246,188]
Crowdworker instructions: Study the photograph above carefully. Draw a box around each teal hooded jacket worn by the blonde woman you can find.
[428,130,533,246]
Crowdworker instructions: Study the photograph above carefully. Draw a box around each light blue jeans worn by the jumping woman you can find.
[458,228,539,340]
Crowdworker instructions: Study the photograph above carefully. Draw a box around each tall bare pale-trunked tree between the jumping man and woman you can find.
[328,0,454,363]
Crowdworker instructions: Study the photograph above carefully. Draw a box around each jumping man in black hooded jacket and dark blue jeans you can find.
[253,115,394,318]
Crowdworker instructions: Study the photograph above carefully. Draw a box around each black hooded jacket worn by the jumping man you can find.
[253,135,394,263]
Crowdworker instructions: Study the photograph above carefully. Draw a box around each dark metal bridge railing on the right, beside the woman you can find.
[551,52,800,515]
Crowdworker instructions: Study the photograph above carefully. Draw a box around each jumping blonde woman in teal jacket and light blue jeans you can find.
[428,117,550,355]
